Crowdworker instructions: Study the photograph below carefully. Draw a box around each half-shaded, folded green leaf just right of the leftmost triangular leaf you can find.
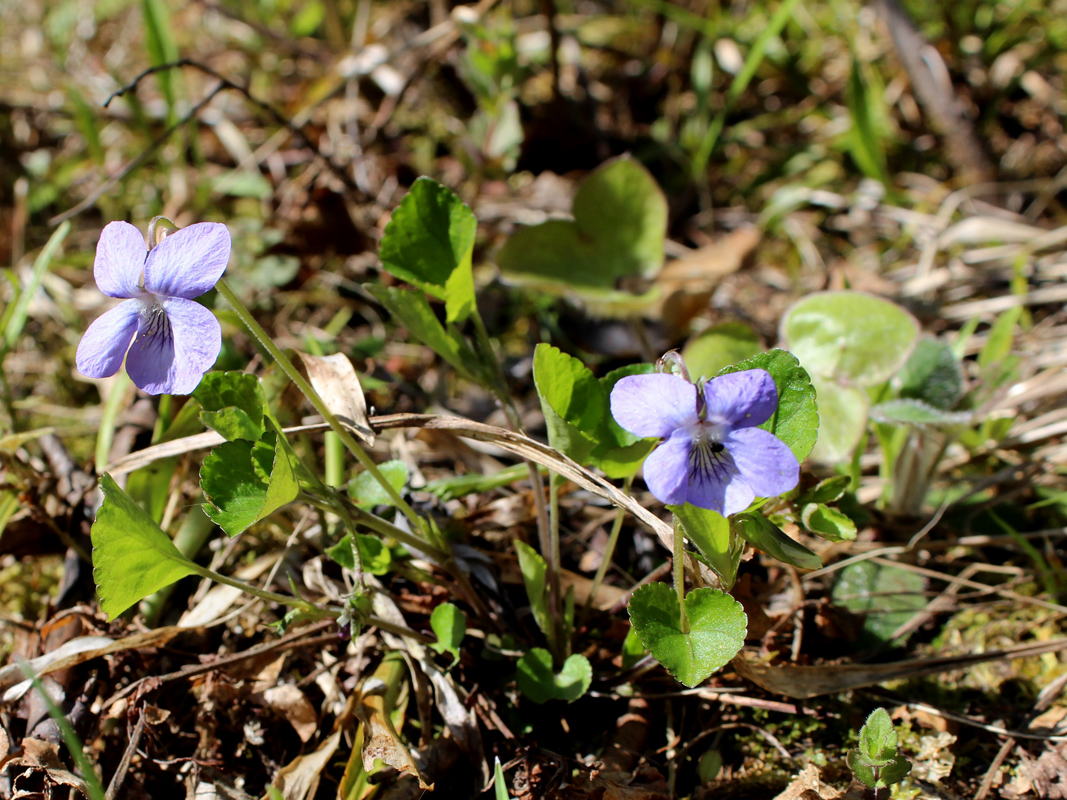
[201,433,300,537]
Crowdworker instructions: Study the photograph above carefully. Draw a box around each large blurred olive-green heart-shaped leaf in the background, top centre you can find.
[497,157,667,291]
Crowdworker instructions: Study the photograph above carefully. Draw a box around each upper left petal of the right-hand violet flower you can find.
[611,373,697,439]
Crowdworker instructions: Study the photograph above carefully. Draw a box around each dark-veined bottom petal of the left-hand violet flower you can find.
[126,298,222,395]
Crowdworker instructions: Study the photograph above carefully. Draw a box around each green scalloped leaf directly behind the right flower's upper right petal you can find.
[718,349,825,461]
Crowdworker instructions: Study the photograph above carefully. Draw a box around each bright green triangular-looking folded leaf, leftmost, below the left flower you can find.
[90,473,197,620]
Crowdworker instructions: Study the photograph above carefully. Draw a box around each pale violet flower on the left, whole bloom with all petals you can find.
[76,222,229,395]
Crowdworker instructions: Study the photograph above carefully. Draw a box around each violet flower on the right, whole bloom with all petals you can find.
[611,369,800,516]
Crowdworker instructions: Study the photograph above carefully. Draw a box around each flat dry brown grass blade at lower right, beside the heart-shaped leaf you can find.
[732,639,1067,700]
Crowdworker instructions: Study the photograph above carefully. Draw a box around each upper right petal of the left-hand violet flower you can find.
[144,222,230,300]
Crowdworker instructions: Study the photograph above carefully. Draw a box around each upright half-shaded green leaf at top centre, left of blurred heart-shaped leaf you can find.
[379,177,478,298]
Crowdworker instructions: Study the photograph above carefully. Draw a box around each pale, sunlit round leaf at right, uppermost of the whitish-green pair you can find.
[780,291,919,386]
